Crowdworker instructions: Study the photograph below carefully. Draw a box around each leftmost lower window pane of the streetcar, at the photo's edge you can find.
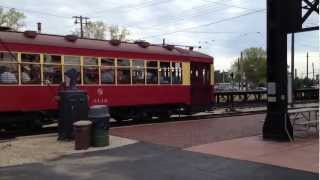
[0,63,18,84]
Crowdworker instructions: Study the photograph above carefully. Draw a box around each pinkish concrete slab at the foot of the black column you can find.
[186,136,319,173]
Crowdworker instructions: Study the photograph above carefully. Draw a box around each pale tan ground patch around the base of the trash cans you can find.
[0,133,137,167]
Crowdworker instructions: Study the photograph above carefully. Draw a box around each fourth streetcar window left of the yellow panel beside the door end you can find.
[132,60,145,84]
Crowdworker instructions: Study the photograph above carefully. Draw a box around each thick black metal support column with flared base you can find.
[263,0,293,141]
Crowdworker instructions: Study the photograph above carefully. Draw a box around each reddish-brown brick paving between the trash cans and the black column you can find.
[110,114,265,148]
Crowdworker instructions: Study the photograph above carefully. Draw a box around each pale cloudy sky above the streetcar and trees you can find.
[0,0,320,77]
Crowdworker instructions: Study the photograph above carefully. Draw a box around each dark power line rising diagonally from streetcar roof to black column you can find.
[141,9,265,39]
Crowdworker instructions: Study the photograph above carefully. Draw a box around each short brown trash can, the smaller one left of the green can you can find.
[73,120,92,150]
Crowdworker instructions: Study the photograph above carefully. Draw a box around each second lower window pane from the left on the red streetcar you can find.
[21,64,41,84]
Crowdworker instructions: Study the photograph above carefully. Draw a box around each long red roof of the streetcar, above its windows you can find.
[0,31,213,63]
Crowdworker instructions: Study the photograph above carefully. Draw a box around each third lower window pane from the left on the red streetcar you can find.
[43,64,62,84]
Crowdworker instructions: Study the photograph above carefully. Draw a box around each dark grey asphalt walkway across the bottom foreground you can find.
[0,143,318,180]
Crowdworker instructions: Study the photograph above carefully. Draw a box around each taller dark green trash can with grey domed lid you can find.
[88,105,110,147]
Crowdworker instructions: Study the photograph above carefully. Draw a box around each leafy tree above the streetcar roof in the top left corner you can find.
[0,8,26,30]
